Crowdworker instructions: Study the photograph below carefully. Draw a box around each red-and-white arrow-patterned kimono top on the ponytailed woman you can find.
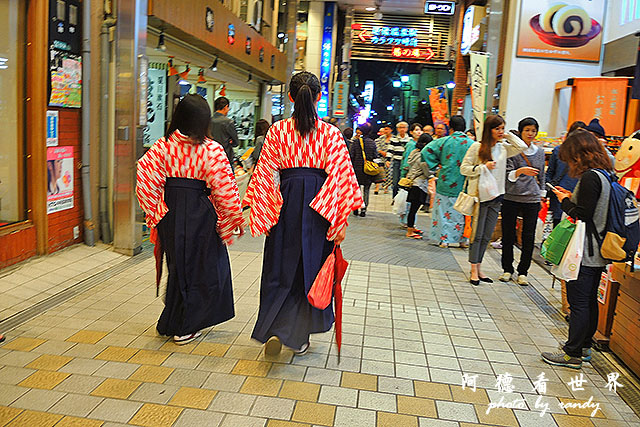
[243,119,364,240]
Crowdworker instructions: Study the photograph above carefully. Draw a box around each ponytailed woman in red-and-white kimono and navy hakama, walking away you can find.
[243,72,363,355]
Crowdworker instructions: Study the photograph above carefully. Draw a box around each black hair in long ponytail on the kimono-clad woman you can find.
[289,71,320,137]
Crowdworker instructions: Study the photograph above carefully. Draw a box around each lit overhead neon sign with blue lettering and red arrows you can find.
[351,12,451,64]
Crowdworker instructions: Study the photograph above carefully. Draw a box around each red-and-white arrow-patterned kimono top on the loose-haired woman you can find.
[136,131,243,245]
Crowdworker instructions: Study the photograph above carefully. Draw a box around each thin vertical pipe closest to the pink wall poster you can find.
[81,1,95,246]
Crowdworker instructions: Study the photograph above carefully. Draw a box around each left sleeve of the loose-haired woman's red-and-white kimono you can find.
[136,138,169,227]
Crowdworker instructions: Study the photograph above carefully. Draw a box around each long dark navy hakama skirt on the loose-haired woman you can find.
[157,178,235,336]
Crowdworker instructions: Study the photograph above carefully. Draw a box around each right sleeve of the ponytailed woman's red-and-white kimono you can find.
[309,132,364,240]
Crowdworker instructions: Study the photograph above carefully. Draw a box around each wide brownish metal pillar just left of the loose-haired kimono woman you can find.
[113,0,147,255]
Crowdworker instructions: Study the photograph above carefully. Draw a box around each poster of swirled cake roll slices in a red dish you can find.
[517,0,605,62]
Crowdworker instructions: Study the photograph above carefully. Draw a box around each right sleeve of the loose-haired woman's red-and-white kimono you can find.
[207,142,243,245]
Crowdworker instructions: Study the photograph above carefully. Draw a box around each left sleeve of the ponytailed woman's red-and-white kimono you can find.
[242,126,282,237]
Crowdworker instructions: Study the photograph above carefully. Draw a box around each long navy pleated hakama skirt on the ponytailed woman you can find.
[252,168,334,349]
